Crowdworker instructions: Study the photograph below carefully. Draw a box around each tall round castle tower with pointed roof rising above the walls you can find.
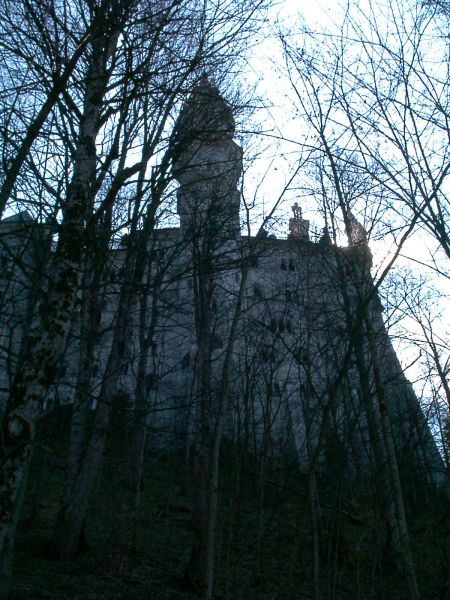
[172,77,242,246]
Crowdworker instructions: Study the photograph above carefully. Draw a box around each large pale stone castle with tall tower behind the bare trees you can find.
[0,80,442,488]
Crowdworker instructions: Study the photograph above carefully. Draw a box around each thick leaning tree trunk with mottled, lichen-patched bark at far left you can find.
[0,24,117,597]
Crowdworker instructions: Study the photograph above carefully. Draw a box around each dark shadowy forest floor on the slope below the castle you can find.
[10,412,450,600]
